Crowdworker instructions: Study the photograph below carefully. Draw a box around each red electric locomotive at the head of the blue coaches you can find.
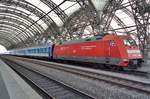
[53,34,143,68]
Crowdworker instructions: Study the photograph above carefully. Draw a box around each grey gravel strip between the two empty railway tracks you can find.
[11,60,150,99]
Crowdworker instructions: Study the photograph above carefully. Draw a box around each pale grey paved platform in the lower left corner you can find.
[0,60,42,99]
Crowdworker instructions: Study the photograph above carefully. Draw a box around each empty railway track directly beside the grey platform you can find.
[4,59,94,99]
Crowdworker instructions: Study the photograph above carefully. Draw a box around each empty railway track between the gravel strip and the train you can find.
[6,58,150,95]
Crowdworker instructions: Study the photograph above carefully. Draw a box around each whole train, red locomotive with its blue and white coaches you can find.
[9,34,143,69]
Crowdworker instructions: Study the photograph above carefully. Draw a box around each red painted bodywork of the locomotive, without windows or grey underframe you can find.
[53,35,143,67]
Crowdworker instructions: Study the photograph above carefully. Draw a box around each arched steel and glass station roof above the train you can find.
[0,0,150,49]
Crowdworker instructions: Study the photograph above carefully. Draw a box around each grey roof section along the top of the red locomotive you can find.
[61,35,104,44]
